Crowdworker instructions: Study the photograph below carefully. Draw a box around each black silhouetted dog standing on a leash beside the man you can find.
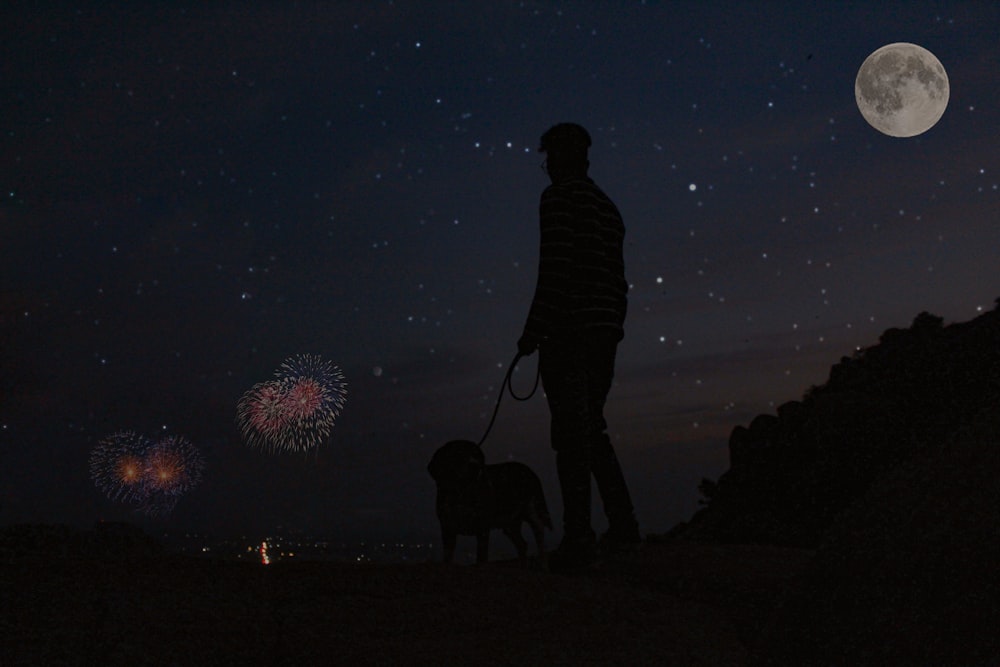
[427,440,552,568]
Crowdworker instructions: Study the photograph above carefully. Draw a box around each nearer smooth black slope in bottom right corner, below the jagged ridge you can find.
[751,396,1000,665]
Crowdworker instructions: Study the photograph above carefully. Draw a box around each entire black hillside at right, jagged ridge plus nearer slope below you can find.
[673,300,1000,665]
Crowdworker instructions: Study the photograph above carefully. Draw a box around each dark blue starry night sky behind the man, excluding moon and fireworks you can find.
[0,0,1000,540]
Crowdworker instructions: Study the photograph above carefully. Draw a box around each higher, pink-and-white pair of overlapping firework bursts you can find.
[236,354,347,452]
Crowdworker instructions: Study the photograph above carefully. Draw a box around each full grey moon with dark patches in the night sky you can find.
[854,42,948,137]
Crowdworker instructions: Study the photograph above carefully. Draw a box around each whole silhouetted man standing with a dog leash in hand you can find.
[517,123,641,569]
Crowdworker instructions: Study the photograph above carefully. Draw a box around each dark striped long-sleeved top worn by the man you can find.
[524,178,628,340]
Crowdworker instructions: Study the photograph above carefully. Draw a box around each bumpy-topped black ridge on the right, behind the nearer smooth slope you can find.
[671,299,1000,548]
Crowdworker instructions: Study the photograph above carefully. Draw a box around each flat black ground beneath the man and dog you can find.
[0,543,813,667]
